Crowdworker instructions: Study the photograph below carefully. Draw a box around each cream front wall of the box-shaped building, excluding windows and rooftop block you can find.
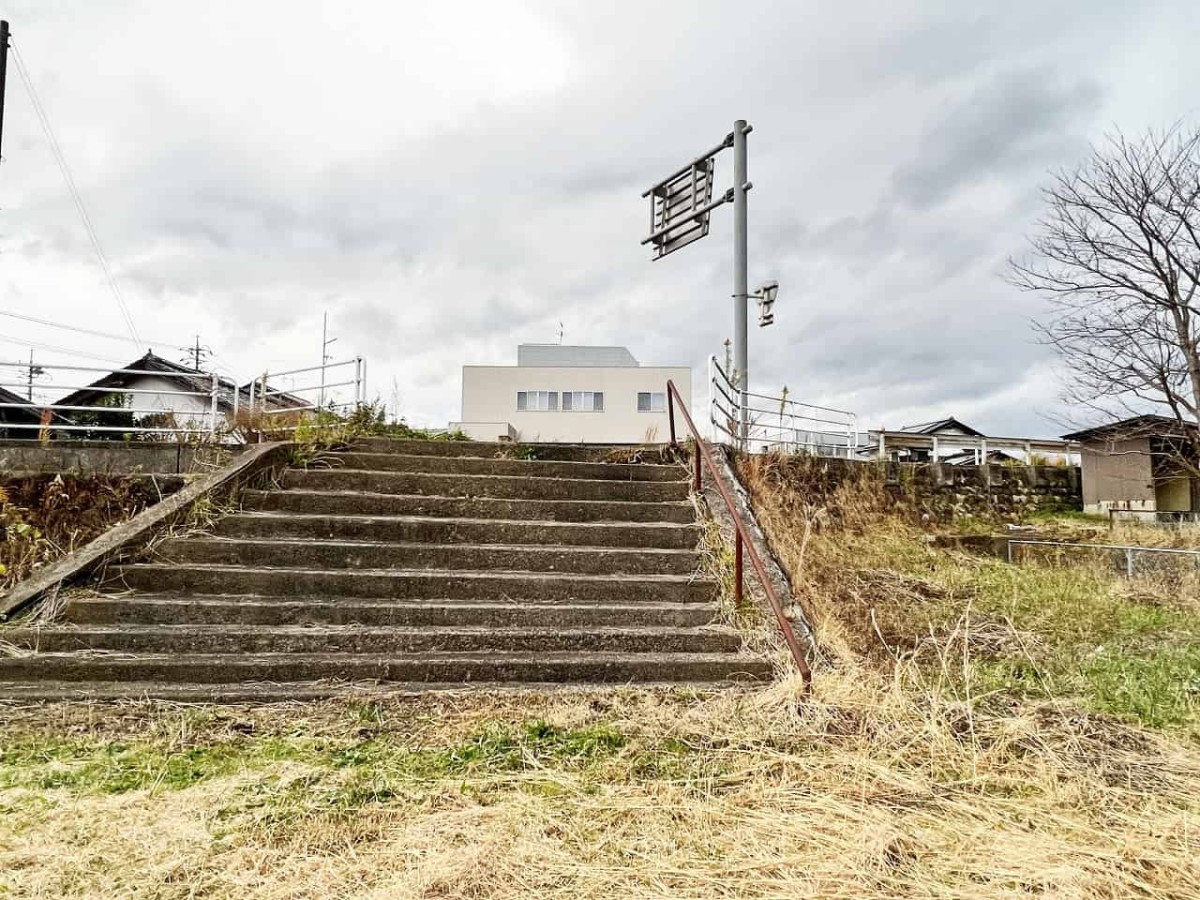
[454,366,691,444]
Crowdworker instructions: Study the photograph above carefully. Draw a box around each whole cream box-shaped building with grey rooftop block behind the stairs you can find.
[450,343,691,444]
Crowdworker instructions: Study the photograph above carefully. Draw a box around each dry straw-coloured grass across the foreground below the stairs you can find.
[0,671,1200,898]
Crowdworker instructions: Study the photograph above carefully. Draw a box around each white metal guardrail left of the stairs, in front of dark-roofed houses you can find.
[0,356,366,442]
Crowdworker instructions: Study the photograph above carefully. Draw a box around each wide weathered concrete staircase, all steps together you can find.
[0,439,770,700]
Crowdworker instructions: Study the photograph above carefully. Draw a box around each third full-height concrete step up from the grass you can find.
[65,594,716,640]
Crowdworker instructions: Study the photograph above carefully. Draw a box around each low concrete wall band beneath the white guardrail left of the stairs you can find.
[0,440,218,475]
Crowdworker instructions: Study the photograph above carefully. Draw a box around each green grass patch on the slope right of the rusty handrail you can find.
[829,529,1200,739]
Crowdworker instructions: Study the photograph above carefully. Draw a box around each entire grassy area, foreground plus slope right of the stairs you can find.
[0,460,1200,898]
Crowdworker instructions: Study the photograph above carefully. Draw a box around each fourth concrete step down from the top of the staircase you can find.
[242,490,696,524]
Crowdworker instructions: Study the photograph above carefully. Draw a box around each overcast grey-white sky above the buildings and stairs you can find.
[0,0,1200,436]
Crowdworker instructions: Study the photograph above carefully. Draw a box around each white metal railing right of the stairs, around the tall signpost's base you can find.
[708,356,859,458]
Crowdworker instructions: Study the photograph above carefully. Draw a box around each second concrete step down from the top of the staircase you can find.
[321,451,688,481]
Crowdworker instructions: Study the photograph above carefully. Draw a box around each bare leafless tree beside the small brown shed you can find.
[1010,126,1200,472]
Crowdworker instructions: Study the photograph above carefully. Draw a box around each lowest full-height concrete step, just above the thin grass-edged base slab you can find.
[0,652,772,692]
